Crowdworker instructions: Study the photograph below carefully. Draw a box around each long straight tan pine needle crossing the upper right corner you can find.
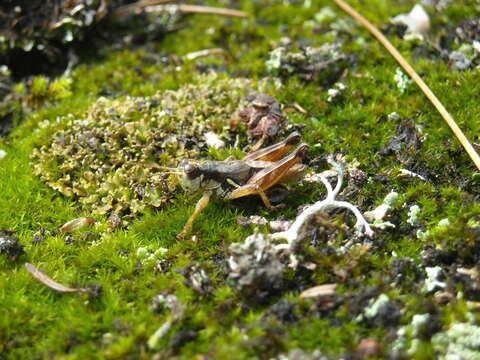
[335,0,480,170]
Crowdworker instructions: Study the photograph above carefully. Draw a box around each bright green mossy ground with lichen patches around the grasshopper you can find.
[0,0,480,359]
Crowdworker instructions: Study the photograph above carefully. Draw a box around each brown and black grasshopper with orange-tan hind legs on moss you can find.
[172,132,308,239]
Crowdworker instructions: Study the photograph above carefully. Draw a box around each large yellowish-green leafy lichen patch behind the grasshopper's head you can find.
[31,74,262,216]
